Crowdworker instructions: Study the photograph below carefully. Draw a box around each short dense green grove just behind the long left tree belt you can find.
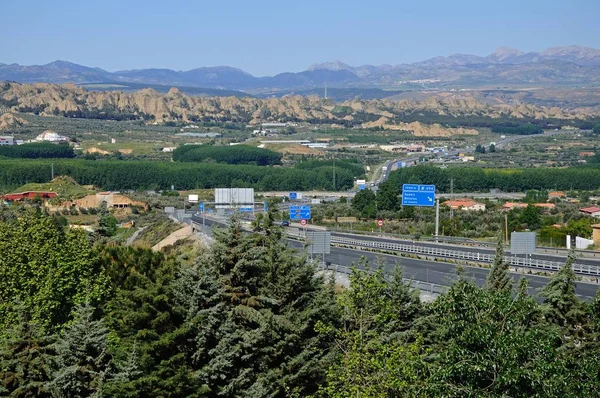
[173,145,281,166]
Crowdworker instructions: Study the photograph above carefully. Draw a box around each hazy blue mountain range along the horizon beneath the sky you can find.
[0,46,600,91]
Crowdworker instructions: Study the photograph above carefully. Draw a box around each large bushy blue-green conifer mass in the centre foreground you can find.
[176,215,335,396]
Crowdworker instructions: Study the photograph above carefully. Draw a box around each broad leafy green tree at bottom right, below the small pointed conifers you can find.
[427,279,572,397]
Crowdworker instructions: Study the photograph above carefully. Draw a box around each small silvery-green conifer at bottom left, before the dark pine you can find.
[50,303,111,398]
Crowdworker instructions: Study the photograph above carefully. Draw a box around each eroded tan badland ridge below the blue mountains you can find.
[0,83,589,134]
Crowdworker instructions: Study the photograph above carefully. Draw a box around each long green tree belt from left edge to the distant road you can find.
[0,159,356,191]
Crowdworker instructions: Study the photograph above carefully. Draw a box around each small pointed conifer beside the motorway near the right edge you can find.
[540,249,586,331]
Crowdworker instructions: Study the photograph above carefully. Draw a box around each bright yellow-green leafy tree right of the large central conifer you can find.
[318,262,425,397]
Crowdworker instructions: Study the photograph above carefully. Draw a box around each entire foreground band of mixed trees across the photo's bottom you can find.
[0,211,600,398]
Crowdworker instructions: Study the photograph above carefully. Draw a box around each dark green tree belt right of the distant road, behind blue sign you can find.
[386,165,600,192]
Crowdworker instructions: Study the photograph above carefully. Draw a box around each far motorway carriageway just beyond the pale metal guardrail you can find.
[331,232,600,266]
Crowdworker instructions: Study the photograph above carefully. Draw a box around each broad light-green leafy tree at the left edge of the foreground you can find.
[0,211,107,329]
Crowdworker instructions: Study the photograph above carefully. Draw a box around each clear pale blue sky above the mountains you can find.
[0,0,600,76]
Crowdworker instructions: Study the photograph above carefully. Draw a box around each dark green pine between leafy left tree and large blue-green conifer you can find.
[100,247,202,397]
